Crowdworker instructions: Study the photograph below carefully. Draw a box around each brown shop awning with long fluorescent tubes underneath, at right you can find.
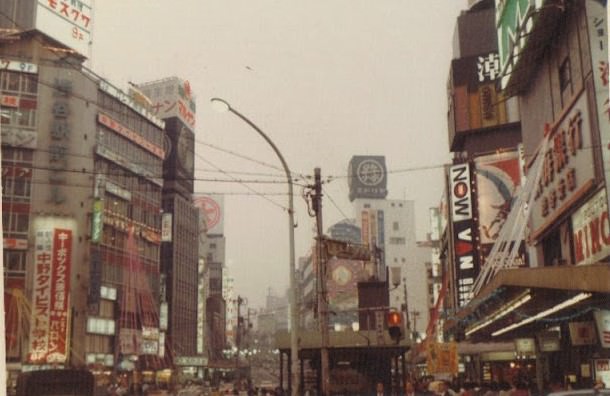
[445,264,610,340]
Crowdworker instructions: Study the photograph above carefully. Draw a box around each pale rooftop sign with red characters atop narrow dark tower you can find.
[139,77,196,131]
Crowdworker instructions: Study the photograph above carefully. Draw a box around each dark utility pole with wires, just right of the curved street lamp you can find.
[312,168,330,396]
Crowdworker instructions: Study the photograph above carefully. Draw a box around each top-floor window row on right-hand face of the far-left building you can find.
[98,91,165,147]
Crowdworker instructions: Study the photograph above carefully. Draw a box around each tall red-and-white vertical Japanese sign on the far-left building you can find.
[28,228,72,364]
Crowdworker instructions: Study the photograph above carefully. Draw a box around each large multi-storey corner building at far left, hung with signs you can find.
[0,28,169,384]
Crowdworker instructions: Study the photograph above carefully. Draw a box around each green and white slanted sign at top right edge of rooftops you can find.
[496,0,544,89]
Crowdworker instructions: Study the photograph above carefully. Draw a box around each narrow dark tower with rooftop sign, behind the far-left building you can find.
[137,77,203,374]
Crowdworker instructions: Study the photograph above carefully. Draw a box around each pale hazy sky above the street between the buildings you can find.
[90,0,467,307]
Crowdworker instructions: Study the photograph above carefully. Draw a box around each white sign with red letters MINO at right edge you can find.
[572,189,610,265]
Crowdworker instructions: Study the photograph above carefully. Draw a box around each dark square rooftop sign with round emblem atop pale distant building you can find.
[347,155,388,201]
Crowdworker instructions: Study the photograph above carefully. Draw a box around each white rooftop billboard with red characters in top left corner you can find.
[36,0,93,56]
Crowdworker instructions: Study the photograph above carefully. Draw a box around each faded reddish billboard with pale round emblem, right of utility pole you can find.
[327,258,367,327]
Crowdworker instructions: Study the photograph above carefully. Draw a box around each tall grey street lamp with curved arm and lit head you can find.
[211,98,299,396]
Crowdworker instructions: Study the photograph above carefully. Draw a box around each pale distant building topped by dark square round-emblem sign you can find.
[348,156,428,338]
